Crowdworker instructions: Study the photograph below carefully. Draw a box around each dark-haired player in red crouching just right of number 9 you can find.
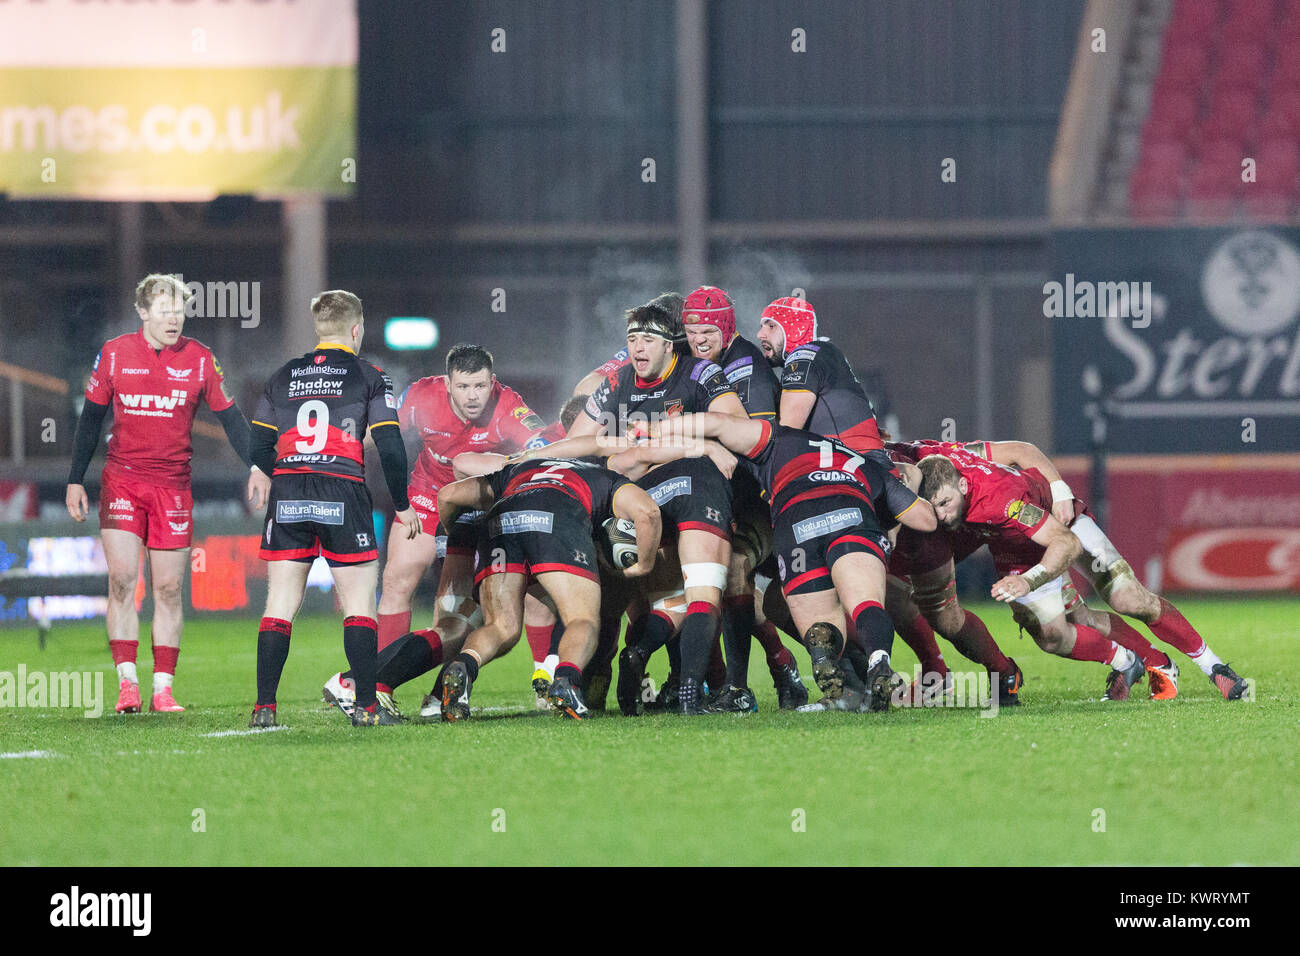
[321,343,546,713]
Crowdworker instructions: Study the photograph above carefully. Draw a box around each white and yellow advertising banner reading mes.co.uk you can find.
[0,0,358,200]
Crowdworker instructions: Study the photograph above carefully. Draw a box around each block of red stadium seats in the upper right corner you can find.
[1128,0,1300,220]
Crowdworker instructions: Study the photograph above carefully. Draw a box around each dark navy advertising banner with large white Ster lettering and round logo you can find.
[1043,229,1300,454]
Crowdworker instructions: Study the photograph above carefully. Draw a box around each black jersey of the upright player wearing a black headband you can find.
[584,355,736,437]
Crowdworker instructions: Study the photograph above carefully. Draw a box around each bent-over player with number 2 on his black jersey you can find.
[438,458,662,722]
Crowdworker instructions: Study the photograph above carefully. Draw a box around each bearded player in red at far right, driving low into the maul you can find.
[919,450,1248,700]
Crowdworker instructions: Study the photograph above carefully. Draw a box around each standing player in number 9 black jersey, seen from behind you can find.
[248,290,420,727]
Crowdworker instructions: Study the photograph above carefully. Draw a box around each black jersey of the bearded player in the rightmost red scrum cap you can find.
[781,338,881,451]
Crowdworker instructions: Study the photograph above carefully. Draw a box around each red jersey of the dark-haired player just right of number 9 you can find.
[398,375,546,489]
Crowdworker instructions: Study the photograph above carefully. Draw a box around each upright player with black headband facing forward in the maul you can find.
[569,293,748,713]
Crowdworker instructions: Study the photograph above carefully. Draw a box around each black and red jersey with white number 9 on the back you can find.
[252,343,398,481]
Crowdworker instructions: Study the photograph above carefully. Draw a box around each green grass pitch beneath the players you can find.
[0,600,1300,865]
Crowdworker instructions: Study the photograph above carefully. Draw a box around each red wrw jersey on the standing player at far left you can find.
[86,326,235,488]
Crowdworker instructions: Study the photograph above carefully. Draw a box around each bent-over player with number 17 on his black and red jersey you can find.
[658,412,939,710]
